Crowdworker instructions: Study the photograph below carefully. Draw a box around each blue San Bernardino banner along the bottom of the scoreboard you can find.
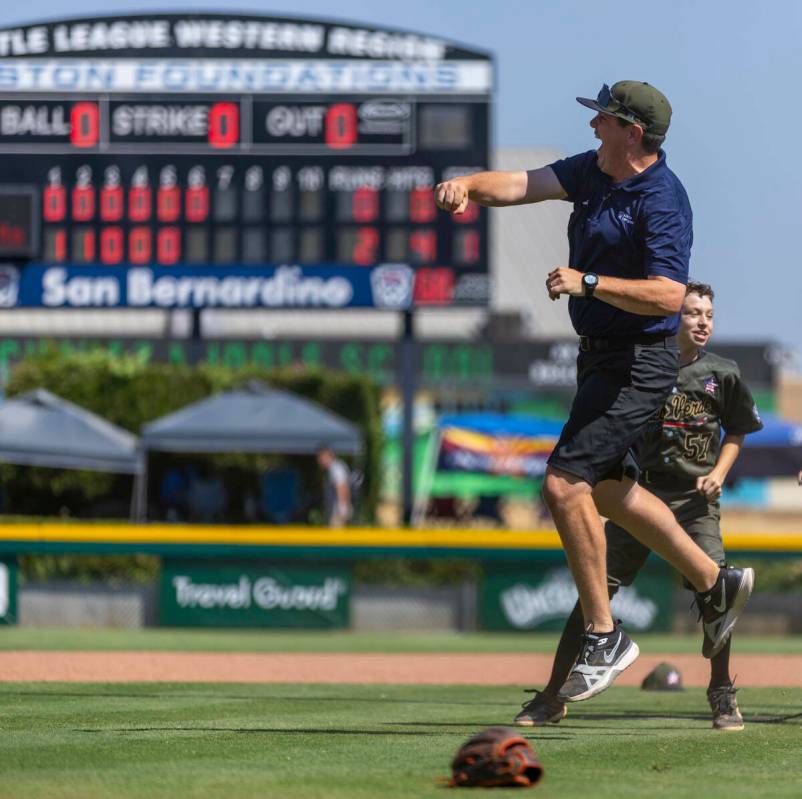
[0,264,415,310]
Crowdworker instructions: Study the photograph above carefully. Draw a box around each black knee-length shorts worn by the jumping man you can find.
[549,339,679,486]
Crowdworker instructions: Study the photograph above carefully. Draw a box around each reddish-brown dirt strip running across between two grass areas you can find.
[0,651,802,687]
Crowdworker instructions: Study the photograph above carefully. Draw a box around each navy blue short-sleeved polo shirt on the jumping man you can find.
[551,150,693,337]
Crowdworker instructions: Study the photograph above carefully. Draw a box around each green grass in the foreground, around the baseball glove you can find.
[0,683,802,799]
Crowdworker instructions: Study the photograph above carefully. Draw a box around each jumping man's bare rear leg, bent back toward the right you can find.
[593,478,719,592]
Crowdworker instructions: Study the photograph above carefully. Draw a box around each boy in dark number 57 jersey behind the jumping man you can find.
[515,282,763,730]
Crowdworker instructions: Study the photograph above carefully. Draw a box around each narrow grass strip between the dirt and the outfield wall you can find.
[0,627,802,656]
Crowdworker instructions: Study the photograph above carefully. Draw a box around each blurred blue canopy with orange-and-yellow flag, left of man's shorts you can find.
[437,414,562,477]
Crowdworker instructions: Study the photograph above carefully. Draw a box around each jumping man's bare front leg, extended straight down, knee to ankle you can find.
[543,466,612,632]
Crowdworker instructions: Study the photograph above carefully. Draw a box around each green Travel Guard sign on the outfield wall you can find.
[159,559,351,628]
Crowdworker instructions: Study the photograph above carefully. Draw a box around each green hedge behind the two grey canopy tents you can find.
[0,345,382,523]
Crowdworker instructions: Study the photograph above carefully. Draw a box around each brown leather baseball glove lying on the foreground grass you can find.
[449,727,543,788]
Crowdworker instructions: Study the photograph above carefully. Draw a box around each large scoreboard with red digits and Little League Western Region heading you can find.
[0,14,492,307]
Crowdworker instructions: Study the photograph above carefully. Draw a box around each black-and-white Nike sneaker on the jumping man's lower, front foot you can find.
[557,624,640,702]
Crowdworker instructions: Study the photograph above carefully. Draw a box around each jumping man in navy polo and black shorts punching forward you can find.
[435,81,754,701]
